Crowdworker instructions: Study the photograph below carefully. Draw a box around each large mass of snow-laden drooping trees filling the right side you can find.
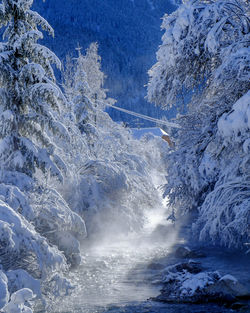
[148,0,250,246]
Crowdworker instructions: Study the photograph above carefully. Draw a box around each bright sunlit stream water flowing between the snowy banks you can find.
[49,214,234,313]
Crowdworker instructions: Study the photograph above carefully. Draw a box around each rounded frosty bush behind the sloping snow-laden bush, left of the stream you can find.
[32,188,86,266]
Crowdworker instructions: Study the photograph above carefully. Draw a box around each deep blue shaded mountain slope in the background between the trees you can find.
[34,0,176,126]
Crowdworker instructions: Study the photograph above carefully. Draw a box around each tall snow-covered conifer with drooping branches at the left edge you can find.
[0,0,67,179]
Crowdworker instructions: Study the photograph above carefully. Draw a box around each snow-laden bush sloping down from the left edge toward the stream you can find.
[0,201,66,278]
